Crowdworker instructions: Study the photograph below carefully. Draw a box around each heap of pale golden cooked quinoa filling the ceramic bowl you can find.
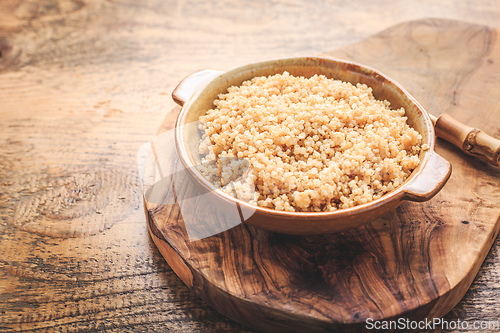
[199,72,426,212]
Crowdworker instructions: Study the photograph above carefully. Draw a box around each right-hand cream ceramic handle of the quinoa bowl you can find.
[404,151,451,201]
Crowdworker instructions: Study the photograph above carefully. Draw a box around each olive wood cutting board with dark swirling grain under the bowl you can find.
[141,19,500,332]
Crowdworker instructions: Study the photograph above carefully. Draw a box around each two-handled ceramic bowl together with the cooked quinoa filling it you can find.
[173,57,451,235]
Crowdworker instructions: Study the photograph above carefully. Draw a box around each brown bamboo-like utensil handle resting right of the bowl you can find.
[433,113,500,167]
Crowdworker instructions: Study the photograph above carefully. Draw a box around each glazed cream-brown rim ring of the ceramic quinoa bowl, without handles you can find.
[174,56,437,220]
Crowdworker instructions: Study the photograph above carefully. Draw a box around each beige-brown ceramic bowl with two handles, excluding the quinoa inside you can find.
[172,57,451,235]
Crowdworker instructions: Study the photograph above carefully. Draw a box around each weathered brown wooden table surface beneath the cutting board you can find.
[0,0,500,332]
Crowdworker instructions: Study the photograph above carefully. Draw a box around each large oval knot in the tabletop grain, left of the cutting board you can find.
[14,171,139,237]
